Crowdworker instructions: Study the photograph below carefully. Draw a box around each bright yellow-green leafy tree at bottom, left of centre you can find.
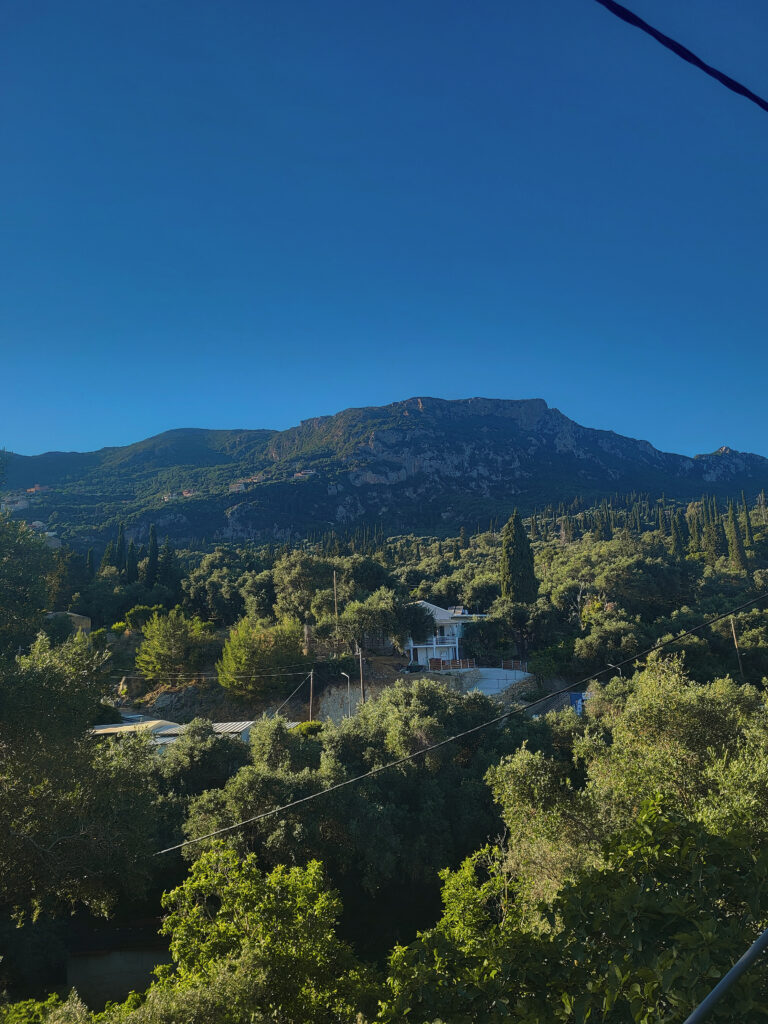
[162,844,373,1024]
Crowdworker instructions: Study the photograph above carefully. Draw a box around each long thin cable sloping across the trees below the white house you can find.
[155,591,768,857]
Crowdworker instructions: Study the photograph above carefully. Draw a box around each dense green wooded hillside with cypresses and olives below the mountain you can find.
[0,492,768,1024]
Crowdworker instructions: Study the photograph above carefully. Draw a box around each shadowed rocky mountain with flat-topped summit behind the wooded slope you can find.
[8,397,768,543]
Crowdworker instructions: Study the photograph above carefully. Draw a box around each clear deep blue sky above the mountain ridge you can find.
[0,0,768,455]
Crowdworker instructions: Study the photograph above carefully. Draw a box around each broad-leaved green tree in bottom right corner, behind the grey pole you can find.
[380,800,768,1024]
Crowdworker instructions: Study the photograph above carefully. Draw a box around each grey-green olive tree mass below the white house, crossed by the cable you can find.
[185,679,536,900]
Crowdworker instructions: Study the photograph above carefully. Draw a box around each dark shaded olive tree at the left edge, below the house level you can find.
[0,635,155,913]
